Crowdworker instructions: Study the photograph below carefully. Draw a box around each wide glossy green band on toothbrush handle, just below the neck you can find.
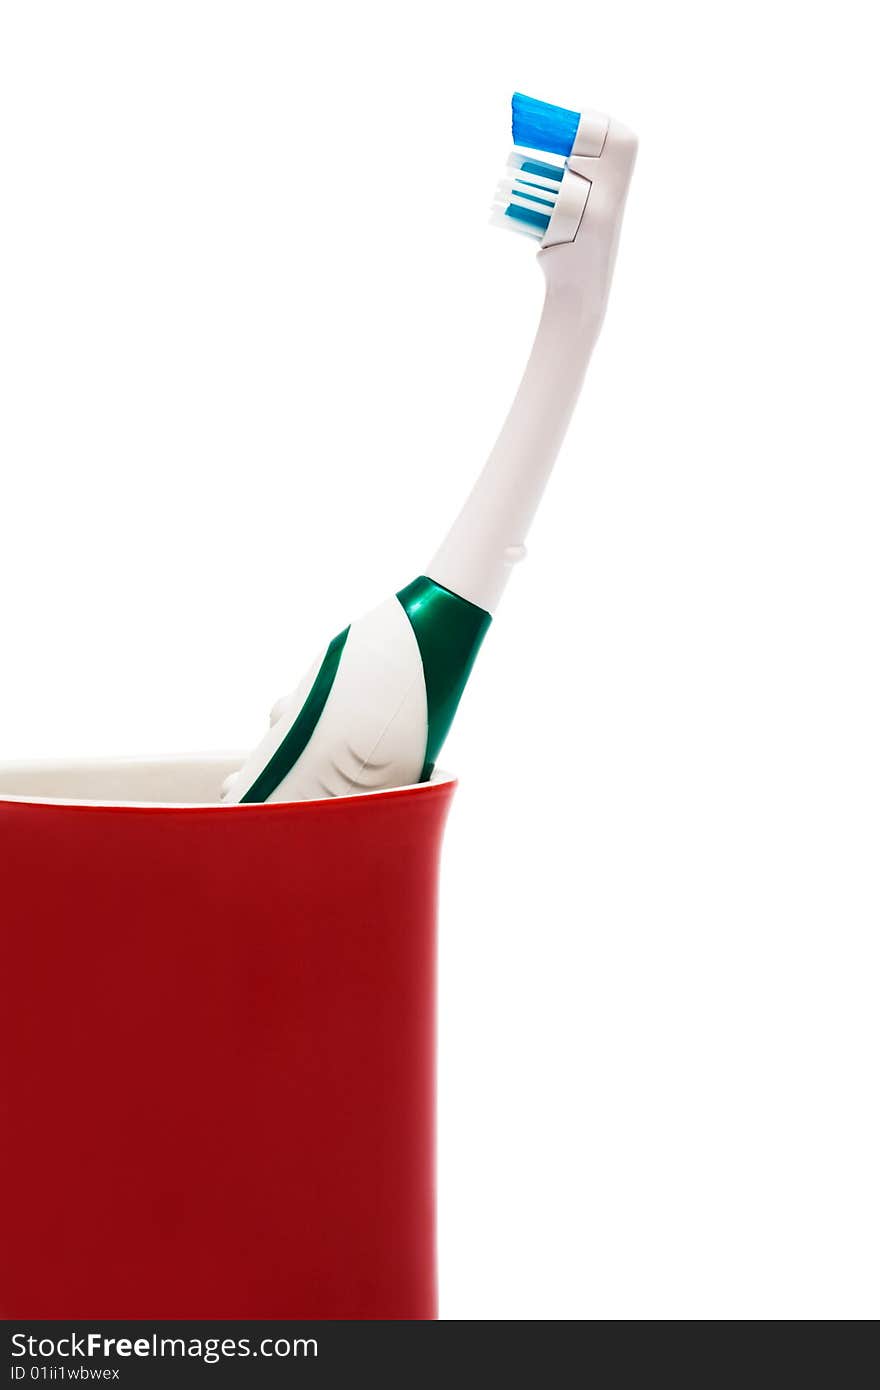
[398,574,492,781]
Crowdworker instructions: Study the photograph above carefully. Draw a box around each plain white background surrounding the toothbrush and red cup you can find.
[0,0,880,1319]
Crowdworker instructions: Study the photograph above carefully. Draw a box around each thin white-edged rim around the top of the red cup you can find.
[0,752,456,816]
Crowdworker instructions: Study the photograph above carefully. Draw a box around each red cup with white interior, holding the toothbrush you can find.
[0,758,455,1319]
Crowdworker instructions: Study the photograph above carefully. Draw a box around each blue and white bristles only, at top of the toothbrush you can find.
[491,92,580,242]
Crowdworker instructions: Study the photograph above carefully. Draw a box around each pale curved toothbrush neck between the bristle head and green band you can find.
[425,265,608,613]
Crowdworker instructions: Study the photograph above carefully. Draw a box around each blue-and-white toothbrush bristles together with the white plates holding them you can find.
[491,92,609,247]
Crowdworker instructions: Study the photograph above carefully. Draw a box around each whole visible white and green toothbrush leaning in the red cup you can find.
[224,93,637,803]
